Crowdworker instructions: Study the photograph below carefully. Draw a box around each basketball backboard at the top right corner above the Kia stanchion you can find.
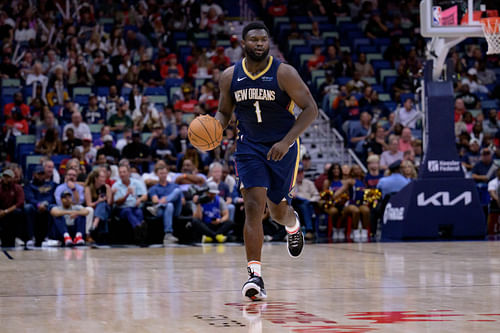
[420,0,500,37]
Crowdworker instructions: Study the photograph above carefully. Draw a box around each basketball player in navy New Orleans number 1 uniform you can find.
[215,22,318,300]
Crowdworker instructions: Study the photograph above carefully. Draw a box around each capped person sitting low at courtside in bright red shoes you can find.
[50,190,89,247]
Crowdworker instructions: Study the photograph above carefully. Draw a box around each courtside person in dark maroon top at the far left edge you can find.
[0,169,24,247]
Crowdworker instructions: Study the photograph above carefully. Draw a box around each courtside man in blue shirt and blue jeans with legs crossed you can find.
[148,164,183,243]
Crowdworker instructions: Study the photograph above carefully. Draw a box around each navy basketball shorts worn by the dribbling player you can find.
[235,137,300,204]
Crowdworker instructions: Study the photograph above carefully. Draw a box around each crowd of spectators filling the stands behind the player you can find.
[0,0,500,246]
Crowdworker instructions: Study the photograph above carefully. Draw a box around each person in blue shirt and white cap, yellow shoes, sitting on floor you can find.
[193,181,234,243]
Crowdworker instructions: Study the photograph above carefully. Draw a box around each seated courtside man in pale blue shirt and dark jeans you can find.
[111,164,148,244]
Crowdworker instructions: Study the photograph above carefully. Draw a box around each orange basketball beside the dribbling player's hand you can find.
[188,115,222,151]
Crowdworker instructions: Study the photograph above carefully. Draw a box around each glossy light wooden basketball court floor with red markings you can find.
[0,242,500,333]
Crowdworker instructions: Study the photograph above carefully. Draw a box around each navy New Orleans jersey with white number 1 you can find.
[231,56,295,143]
